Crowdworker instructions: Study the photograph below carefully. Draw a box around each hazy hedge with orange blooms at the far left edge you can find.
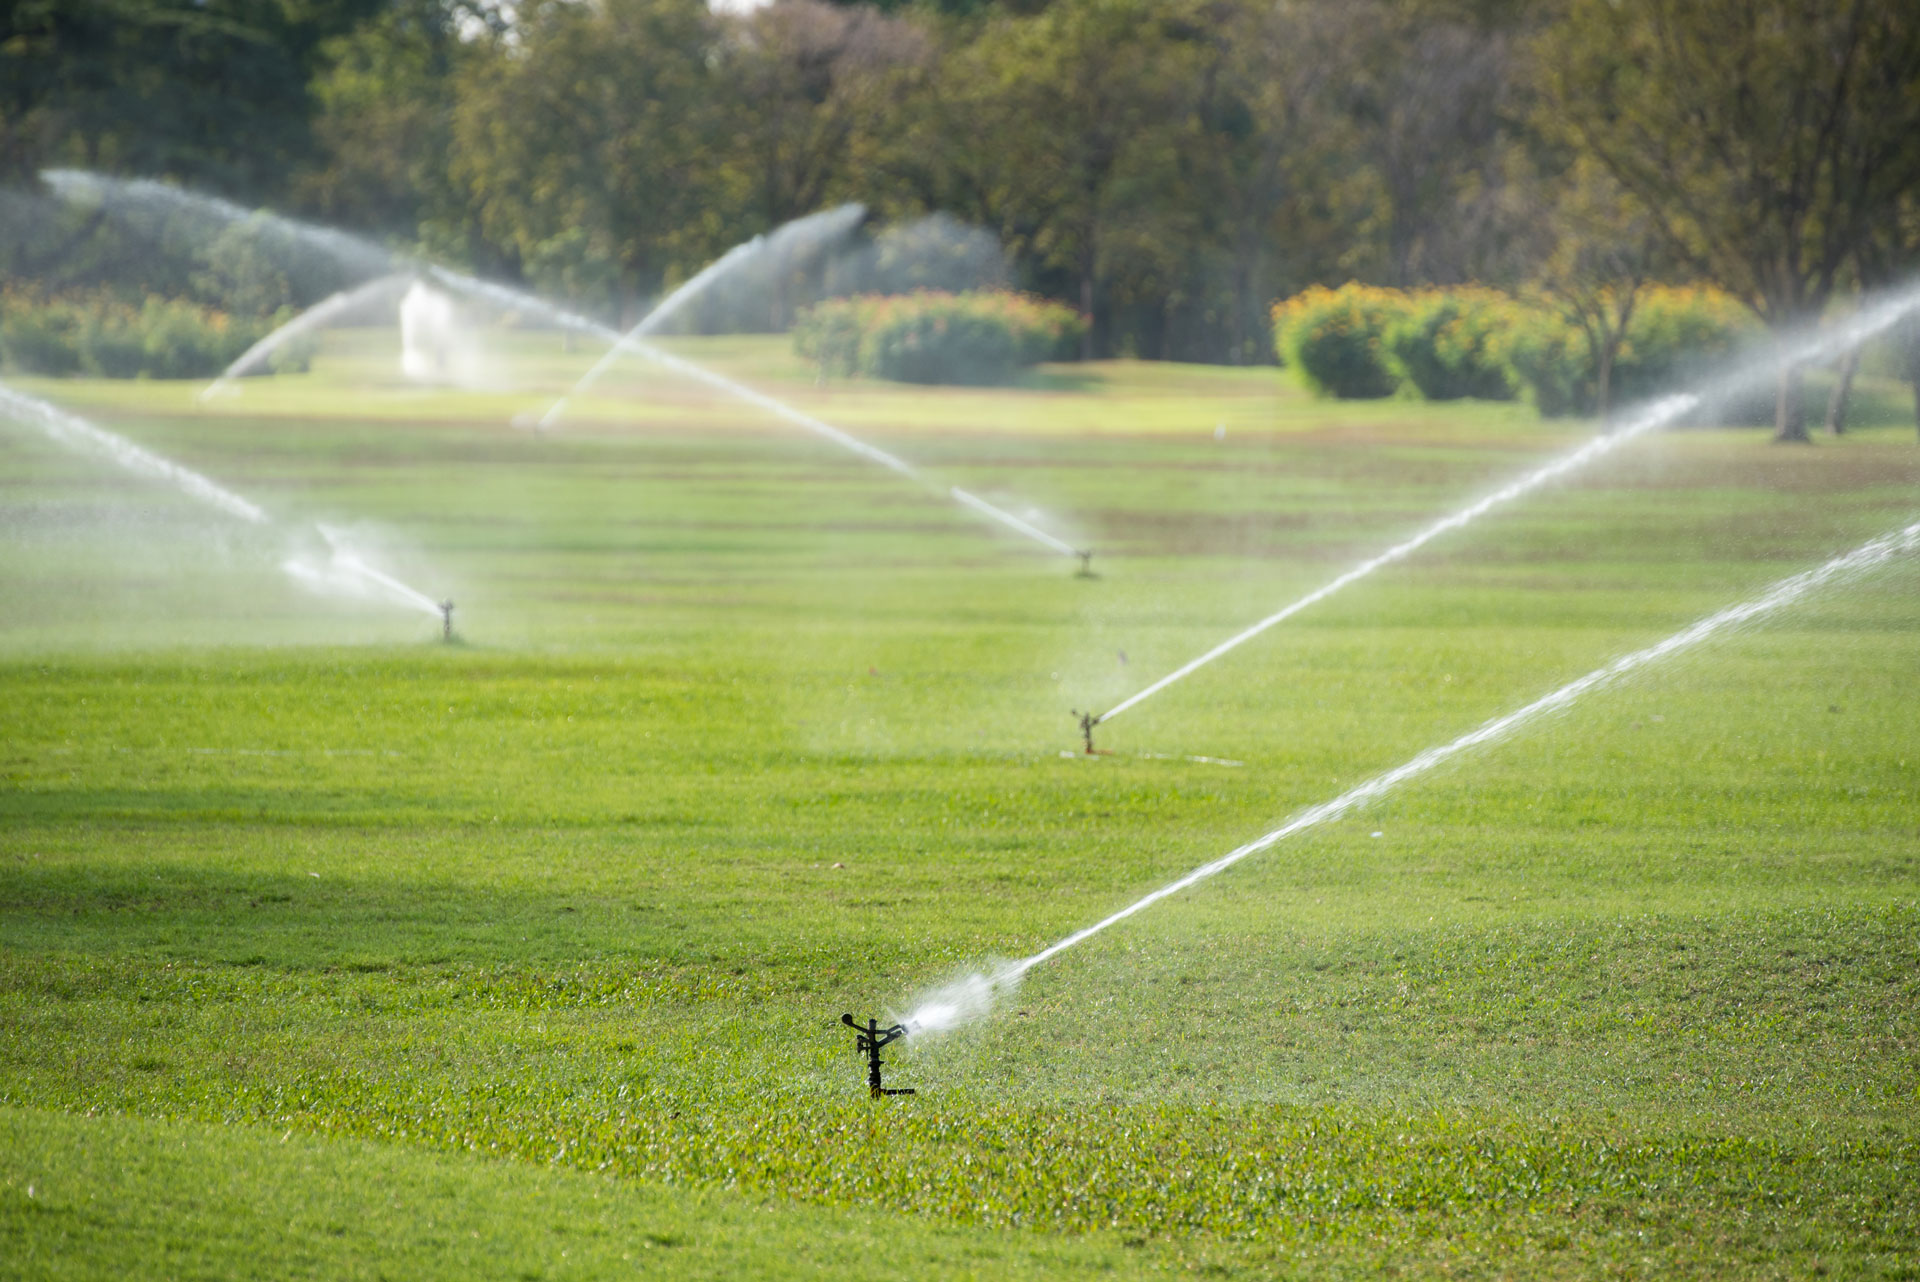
[0,294,299,378]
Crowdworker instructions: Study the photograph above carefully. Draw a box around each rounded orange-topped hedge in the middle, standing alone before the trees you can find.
[793,290,1085,384]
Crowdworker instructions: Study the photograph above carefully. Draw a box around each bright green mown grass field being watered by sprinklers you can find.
[0,334,1920,1278]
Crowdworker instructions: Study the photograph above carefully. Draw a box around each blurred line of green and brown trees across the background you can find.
[0,0,1920,438]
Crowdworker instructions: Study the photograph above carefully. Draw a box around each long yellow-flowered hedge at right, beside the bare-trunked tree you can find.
[1273,284,1759,416]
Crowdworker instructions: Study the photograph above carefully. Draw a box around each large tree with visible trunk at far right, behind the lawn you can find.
[1536,0,1920,441]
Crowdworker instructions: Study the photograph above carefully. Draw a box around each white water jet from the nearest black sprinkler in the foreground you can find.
[902,522,1920,1033]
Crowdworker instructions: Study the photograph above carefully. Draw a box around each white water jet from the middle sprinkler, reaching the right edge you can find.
[1092,290,1920,725]
